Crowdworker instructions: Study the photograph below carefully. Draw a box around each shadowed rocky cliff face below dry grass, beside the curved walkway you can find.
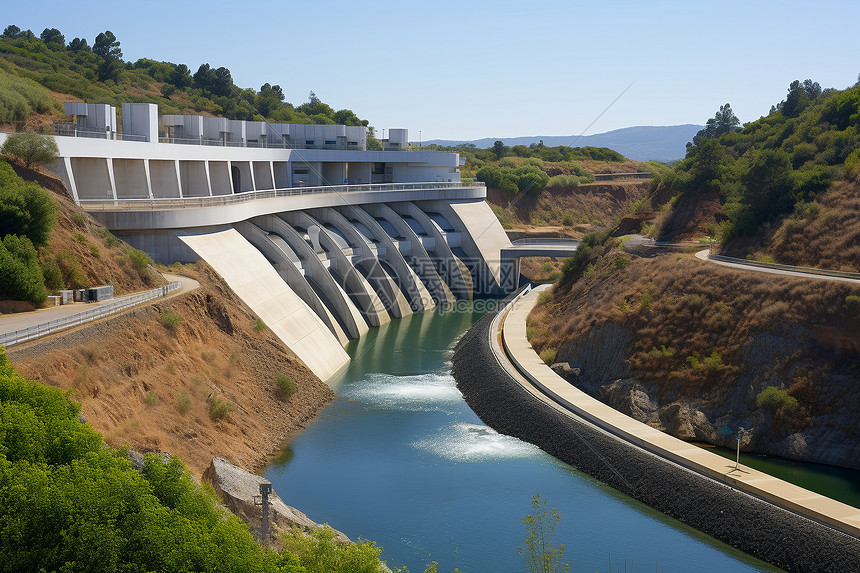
[553,323,860,469]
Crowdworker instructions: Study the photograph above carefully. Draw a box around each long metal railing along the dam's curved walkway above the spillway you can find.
[79,181,484,211]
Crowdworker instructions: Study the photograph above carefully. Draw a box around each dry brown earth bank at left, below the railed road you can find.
[8,263,334,479]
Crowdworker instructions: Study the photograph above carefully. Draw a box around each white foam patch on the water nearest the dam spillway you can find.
[343,373,463,411]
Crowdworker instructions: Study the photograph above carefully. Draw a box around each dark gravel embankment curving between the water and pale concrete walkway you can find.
[453,300,860,572]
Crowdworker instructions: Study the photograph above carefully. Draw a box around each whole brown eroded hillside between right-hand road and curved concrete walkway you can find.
[528,241,860,468]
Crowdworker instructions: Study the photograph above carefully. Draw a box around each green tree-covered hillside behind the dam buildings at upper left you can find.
[0,25,375,139]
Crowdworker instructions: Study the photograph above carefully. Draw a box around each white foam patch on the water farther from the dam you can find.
[412,422,540,462]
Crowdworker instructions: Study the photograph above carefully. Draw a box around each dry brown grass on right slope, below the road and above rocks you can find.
[530,248,860,406]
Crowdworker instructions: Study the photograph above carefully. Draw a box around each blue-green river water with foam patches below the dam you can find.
[265,311,778,573]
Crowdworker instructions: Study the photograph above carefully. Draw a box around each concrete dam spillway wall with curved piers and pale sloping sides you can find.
[153,199,515,380]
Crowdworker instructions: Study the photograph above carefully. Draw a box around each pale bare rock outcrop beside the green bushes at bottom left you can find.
[203,458,350,543]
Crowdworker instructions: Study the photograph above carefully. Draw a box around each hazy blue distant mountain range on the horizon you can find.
[423,124,704,161]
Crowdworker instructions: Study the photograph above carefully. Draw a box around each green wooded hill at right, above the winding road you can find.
[651,80,860,271]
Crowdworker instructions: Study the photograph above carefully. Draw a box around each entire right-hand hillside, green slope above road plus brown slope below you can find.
[528,81,860,468]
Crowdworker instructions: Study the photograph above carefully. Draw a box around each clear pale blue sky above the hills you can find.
[6,0,860,141]
